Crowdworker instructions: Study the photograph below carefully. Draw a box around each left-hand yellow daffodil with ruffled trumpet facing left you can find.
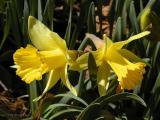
[13,16,77,95]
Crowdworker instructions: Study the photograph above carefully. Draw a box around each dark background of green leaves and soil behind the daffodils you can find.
[0,0,160,120]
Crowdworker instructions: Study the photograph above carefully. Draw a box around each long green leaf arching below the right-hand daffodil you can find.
[77,92,146,120]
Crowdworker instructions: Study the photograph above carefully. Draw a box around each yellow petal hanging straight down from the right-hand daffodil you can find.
[97,62,110,96]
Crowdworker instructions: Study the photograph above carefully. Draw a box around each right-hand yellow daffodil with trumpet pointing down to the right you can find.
[70,31,150,95]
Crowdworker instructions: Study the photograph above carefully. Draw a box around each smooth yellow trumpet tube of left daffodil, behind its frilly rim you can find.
[38,49,67,70]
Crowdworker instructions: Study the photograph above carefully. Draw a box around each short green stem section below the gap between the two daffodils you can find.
[78,71,85,97]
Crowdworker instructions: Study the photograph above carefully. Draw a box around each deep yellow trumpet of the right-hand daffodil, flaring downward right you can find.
[106,50,145,90]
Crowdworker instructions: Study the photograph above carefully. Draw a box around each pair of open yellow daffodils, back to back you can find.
[13,16,149,95]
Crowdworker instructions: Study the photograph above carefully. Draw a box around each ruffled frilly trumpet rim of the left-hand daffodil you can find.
[13,45,48,83]
